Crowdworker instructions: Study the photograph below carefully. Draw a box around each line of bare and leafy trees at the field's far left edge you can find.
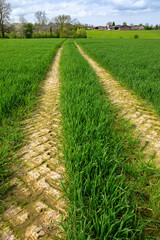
[0,0,87,38]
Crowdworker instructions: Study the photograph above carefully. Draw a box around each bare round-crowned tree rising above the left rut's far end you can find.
[54,15,71,36]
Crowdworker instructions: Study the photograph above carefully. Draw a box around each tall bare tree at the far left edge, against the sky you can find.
[0,0,11,38]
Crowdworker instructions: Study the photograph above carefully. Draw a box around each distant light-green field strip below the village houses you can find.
[87,30,160,39]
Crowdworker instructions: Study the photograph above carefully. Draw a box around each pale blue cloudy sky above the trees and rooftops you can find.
[6,0,160,25]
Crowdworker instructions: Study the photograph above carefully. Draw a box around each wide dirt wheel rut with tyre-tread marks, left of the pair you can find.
[0,47,65,240]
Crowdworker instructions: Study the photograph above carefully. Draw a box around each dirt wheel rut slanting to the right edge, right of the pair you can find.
[76,44,160,166]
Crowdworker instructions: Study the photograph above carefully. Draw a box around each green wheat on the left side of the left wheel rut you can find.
[0,39,64,206]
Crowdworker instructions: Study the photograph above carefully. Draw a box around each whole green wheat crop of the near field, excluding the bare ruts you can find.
[0,38,160,240]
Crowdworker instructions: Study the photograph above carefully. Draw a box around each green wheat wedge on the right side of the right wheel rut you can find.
[76,39,160,114]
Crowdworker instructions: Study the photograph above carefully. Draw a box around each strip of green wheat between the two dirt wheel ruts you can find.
[60,40,159,240]
